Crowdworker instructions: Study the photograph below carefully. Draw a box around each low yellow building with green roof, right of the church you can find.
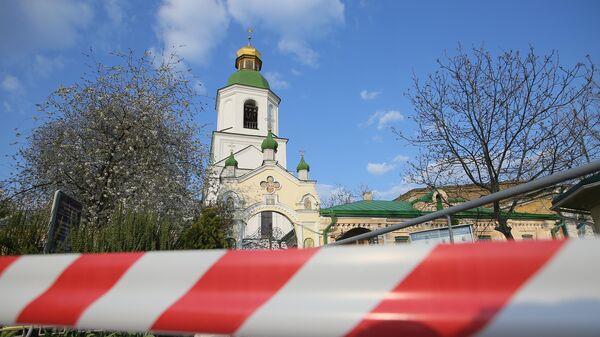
[321,185,591,244]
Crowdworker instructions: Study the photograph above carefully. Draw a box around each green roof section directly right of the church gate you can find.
[321,200,422,217]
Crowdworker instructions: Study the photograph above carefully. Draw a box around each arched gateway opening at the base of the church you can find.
[242,211,298,249]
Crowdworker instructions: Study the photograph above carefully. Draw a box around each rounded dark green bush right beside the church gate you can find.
[180,206,232,249]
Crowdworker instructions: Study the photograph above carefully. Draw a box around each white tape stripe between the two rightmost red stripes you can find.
[237,246,432,336]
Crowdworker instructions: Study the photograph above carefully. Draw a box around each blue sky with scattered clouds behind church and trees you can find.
[0,0,600,199]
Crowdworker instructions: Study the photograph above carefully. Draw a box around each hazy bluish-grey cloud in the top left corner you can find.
[0,0,94,56]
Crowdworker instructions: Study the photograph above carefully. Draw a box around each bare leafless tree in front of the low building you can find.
[395,47,600,239]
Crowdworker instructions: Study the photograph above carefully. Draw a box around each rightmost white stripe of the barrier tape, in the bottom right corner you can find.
[478,240,600,337]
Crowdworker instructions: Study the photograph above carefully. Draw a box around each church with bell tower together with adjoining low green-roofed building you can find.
[206,44,591,249]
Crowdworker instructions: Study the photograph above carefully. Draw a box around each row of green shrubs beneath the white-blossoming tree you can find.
[0,207,232,255]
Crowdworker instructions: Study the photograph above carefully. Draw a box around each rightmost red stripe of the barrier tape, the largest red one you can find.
[348,241,562,337]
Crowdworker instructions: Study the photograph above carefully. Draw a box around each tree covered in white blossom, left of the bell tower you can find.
[4,52,205,225]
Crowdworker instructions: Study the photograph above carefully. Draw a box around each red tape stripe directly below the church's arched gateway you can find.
[152,249,315,334]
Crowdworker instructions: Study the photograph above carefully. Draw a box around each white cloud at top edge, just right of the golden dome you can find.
[227,0,344,67]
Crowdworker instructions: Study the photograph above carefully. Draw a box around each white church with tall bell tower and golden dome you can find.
[208,39,320,249]
